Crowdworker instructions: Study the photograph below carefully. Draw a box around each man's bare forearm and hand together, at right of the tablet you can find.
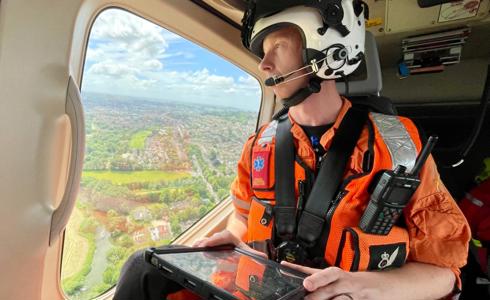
[282,262,456,300]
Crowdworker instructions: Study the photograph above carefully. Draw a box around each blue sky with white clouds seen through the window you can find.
[82,9,262,111]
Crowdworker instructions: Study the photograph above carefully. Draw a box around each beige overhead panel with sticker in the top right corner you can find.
[386,0,490,33]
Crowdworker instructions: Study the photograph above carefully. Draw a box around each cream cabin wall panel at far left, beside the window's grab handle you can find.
[0,0,81,299]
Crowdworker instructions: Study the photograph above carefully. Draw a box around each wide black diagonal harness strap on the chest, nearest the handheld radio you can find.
[294,107,368,247]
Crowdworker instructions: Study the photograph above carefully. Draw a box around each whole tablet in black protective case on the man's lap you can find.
[145,245,307,300]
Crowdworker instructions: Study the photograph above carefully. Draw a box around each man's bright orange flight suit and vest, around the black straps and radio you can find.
[231,98,470,288]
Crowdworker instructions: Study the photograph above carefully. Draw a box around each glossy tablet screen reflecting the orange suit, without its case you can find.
[157,250,305,300]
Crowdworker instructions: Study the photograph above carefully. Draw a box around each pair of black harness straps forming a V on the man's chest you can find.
[274,107,368,260]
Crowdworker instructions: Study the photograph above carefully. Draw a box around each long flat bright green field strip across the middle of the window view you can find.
[82,171,189,184]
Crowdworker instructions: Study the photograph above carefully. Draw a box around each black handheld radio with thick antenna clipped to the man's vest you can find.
[359,136,438,235]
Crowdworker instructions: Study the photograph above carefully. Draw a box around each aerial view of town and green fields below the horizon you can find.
[61,93,257,299]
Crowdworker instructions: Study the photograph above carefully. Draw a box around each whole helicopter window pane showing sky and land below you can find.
[61,8,262,299]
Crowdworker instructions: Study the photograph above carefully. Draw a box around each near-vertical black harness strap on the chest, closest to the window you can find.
[274,114,296,240]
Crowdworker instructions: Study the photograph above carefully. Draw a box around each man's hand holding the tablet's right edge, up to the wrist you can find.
[281,261,374,300]
